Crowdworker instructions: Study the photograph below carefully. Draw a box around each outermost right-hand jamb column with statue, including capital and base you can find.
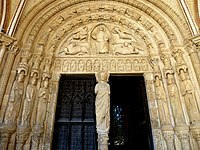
[173,48,200,149]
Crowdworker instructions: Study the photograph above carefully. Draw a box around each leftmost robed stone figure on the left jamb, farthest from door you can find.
[4,70,25,124]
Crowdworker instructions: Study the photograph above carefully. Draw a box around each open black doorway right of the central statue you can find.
[109,75,154,150]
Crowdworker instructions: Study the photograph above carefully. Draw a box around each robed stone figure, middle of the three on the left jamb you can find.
[21,72,38,127]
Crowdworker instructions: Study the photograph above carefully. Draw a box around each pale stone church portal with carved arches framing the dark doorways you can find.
[0,0,200,150]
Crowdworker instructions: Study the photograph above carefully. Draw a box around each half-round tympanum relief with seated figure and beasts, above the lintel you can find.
[57,23,147,57]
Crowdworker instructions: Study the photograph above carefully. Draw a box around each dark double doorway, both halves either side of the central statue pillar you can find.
[52,75,153,150]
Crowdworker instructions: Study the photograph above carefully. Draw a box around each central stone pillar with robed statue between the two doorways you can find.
[95,71,110,150]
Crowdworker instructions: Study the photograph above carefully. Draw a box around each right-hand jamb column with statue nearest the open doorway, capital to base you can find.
[151,58,175,150]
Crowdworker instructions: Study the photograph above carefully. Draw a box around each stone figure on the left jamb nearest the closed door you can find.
[36,77,50,127]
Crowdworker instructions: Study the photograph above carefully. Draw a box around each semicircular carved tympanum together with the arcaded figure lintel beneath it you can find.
[50,23,150,72]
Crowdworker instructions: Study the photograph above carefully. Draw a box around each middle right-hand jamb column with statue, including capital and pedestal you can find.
[161,53,190,150]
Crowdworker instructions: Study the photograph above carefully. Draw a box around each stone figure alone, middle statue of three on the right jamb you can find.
[166,73,185,125]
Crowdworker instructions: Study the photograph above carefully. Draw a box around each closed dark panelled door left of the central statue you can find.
[52,75,97,150]
